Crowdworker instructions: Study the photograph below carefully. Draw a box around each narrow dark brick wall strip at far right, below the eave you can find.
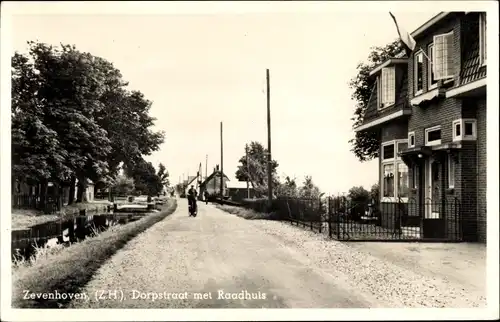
[476,99,487,242]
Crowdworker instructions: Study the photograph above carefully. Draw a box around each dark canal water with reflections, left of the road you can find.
[11,210,157,260]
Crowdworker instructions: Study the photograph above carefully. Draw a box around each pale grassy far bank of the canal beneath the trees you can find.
[11,200,119,229]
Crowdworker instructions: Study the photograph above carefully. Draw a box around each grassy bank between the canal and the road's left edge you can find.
[12,199,177,308]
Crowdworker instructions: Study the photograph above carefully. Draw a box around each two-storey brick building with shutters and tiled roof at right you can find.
[355,12,486,242]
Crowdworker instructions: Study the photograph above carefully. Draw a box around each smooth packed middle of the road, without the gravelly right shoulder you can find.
[68,199,376,308]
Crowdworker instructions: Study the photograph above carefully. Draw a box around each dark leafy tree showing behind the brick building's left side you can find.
[349,40,403,162]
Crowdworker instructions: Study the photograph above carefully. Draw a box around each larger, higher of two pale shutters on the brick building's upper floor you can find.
[432,31,454,80]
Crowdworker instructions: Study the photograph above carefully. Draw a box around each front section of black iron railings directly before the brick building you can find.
[328,197,462,242]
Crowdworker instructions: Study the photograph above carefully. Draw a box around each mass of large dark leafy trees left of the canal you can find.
[12,42,168,203]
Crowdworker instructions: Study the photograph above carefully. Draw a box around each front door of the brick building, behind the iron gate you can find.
[423,157,444,238]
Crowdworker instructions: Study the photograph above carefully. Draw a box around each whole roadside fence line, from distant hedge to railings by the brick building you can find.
[219,196,464,242]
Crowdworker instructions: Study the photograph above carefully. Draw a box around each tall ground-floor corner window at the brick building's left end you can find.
[380,139,409,202]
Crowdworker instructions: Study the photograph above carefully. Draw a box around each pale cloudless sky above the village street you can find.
[6,2,437,193]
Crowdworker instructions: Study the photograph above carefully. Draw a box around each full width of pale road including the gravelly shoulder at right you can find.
[70,199,485,308]
